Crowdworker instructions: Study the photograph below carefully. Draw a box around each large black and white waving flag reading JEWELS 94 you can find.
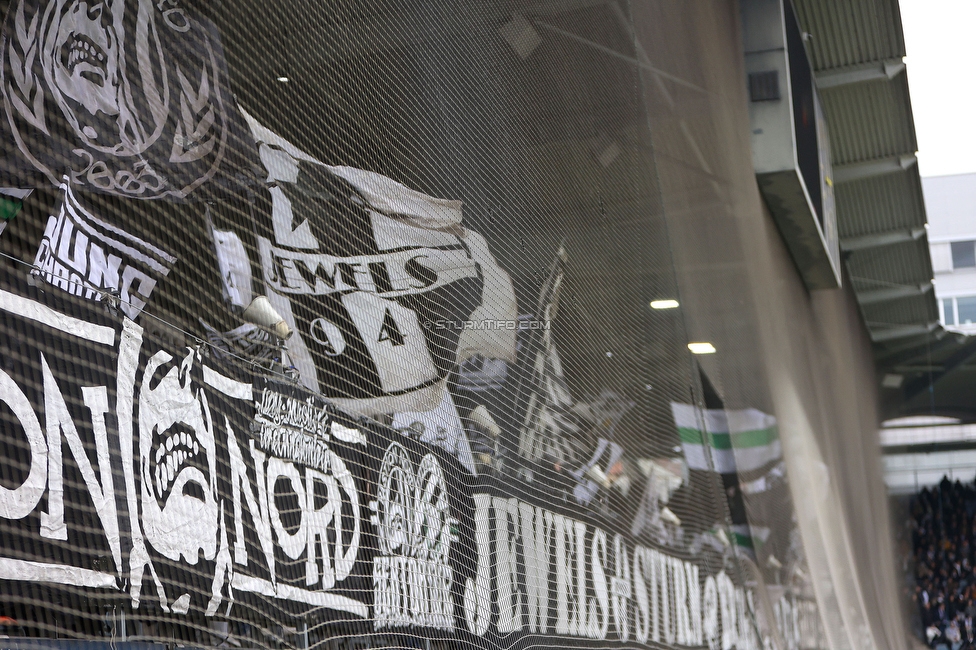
[215,109,515,422]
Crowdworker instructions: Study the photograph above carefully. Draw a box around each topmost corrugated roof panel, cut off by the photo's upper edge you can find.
[794,0,905,71]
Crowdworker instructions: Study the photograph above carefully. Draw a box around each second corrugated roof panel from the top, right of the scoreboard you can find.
[821,74,918,165]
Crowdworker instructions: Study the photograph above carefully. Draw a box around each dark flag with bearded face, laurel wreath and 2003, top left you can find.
[0,0,251,199]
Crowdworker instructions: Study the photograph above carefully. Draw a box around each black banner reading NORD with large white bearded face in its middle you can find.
[0,276,470,625]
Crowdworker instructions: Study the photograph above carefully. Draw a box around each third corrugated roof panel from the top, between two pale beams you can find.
[834,167,925,239]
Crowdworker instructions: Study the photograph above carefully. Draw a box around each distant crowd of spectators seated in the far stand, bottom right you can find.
[909,478,976,650]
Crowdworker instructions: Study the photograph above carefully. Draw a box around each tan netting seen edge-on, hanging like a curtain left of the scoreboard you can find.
[632,1,906,648]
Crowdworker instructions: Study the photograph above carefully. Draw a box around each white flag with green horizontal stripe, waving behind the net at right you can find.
[671,402,783,474]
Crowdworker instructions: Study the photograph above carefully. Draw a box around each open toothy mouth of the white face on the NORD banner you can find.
[149,422,210,507]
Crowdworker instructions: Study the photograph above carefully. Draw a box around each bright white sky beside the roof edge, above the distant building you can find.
[901,0,976,176]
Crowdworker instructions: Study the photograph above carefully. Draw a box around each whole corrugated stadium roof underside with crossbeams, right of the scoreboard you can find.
[795,0,976,420]
